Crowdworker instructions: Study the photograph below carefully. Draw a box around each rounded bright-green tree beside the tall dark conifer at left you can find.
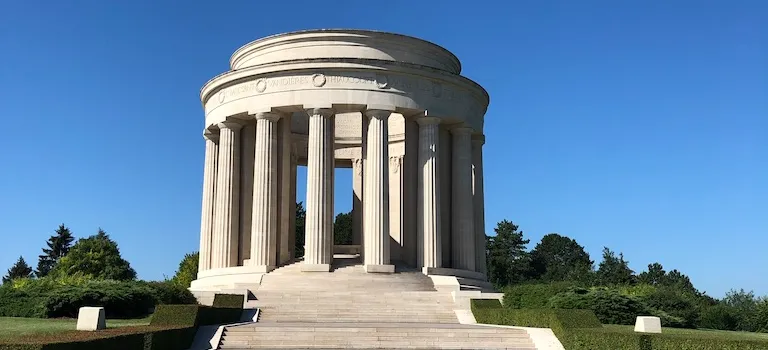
[51,228,136,280]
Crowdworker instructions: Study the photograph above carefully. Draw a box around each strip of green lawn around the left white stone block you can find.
[0,317,149,338]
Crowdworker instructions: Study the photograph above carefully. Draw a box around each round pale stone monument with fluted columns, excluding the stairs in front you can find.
[191,30,489,292]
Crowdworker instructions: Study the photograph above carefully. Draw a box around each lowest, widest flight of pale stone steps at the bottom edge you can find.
[220,322,535,350]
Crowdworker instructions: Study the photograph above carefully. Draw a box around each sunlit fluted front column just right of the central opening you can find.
[363,110,395,272]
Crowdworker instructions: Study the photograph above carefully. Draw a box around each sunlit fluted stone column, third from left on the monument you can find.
[250,113,280,272]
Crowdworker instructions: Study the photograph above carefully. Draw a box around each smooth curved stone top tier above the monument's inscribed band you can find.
[230,29,461,74]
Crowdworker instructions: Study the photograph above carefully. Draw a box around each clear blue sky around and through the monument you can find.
[0,0,768,297]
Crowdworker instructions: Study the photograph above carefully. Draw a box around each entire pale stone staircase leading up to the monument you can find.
[213,255,535,349]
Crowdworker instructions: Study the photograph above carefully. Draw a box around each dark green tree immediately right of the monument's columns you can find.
[487,220,532,286]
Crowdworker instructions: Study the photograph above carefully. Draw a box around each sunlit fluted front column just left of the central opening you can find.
[302,108,334,272]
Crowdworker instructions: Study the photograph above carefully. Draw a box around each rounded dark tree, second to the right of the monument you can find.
[531,233,594,281]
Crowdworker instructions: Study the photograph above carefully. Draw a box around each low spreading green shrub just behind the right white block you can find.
[549,288,650,325]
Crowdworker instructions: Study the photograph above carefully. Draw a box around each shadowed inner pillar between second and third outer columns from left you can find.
[237,122,256,265]
